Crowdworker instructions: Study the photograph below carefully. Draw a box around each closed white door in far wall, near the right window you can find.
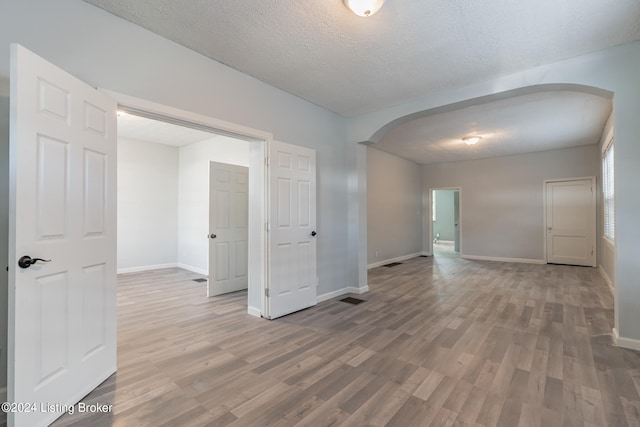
[546,178,596,267]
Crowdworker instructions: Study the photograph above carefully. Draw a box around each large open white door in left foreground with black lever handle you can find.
[7,45,117,427]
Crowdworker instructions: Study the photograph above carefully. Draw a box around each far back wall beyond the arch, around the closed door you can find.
[422,144,600,260]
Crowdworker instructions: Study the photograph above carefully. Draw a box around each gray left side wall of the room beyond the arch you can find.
[367,148,422,264]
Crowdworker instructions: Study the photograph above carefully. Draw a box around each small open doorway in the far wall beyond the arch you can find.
[429,188,460,258]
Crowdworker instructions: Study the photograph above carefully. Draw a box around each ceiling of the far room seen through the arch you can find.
[373,91,612,164]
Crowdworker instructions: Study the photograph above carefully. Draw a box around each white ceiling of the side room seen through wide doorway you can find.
[118,112,217,147]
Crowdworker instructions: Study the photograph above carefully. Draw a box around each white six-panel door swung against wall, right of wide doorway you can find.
[264,141,318,319]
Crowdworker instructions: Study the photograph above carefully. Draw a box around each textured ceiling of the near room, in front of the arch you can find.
[85,0,640,116]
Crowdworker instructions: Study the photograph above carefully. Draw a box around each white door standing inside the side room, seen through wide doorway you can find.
[207,162,249,297]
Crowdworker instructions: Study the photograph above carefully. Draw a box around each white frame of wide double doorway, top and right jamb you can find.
[100,89,273,317]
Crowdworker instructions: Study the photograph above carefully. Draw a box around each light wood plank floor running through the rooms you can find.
[55,257,640,427]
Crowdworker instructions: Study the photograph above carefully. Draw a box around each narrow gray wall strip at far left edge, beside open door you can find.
[0,96,9,388]
